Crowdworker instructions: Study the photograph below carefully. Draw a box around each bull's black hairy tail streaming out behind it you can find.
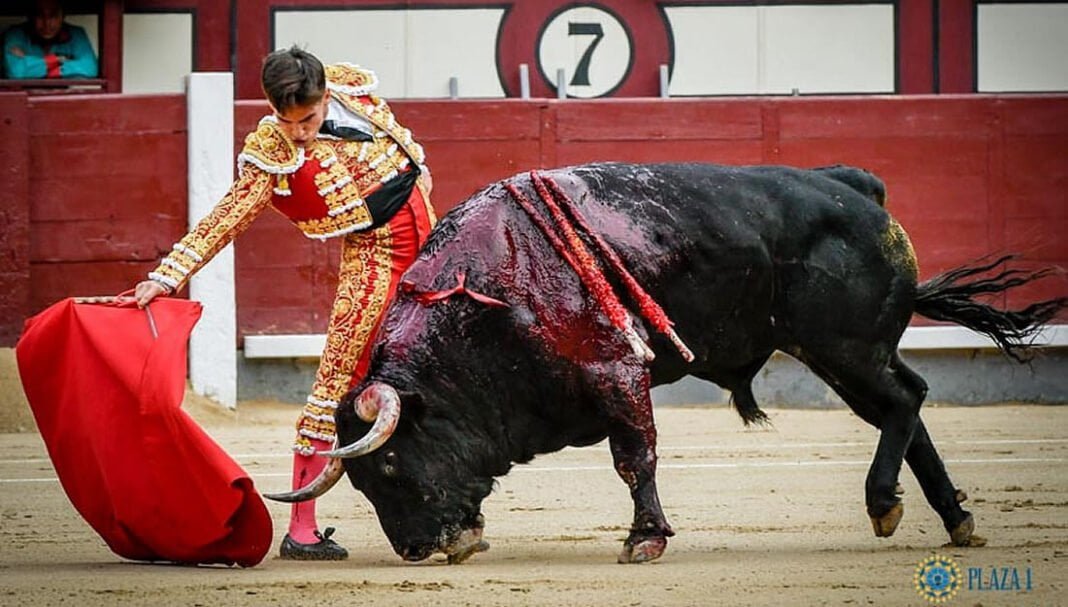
[915,255,1068,362]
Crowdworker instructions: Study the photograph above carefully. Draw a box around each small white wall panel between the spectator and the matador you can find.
[123,13,193,93]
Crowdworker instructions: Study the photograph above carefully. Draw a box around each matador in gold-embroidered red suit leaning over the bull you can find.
[135,48,436,560]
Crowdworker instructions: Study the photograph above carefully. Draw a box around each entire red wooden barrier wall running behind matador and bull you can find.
[0,95,1068,343]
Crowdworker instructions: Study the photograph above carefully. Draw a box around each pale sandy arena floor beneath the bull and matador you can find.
[0,382,1068,607]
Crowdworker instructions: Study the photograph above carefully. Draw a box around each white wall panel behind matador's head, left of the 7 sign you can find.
[273,9,504,97]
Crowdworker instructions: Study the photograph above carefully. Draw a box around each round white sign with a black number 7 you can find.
[537,5,634,98]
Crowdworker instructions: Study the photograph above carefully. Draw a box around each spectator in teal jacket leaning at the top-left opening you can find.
[3,0,97,78]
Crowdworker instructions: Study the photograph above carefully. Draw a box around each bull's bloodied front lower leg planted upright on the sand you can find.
[609,415,675,563]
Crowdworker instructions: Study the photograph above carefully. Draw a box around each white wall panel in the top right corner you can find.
[975,3,1068,92]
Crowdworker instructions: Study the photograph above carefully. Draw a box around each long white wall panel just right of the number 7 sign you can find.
[664,4,895,95]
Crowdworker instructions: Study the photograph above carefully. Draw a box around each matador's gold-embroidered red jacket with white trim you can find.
[148,63,425,290]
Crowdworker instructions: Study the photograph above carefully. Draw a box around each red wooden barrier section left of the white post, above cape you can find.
[27,95,188,320]
